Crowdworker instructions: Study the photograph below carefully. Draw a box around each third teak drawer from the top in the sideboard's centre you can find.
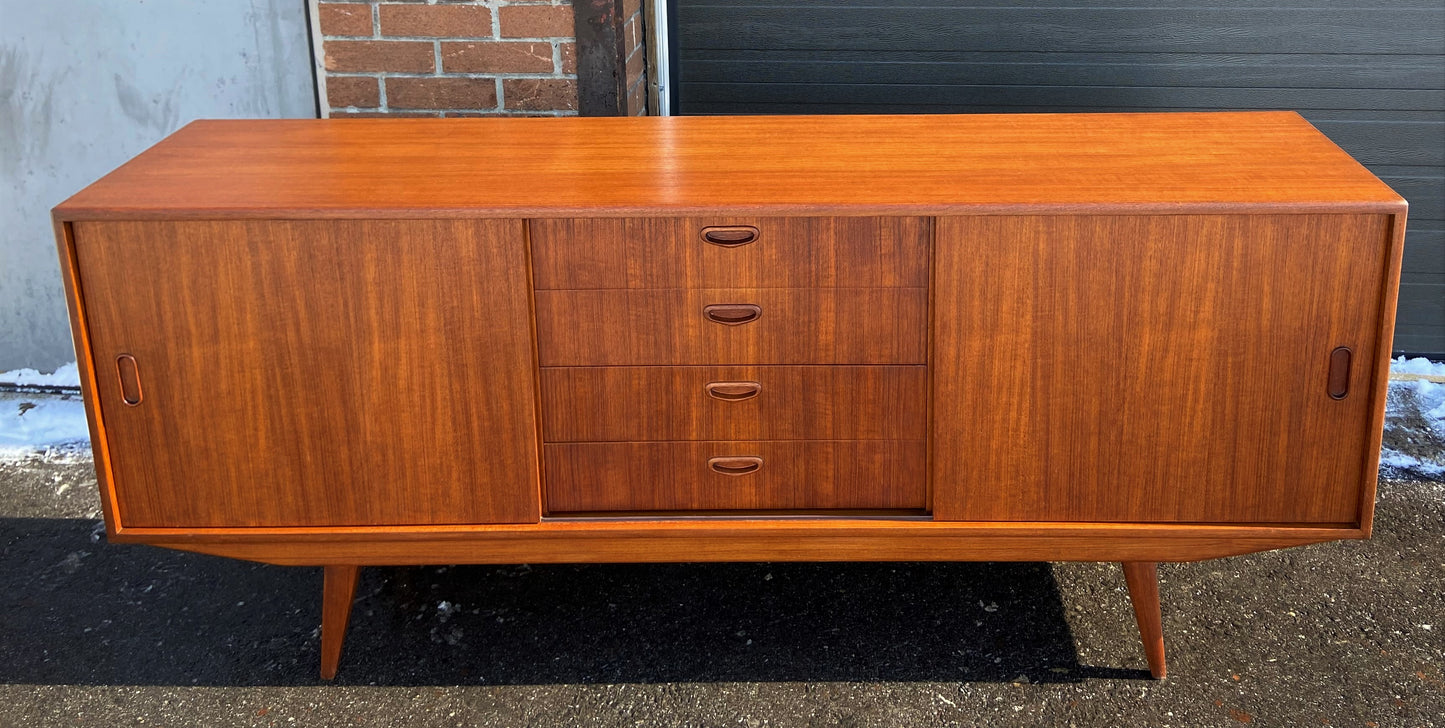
[542,367,928,442]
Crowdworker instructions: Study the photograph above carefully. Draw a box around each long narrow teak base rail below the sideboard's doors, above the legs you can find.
[127,516,1364,566]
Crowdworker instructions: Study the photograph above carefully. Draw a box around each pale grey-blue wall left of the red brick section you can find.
[0,0,315,371]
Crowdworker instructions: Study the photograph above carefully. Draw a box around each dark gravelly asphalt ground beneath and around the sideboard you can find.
[0,392,1445,728]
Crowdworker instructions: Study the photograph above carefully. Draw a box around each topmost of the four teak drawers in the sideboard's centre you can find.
[529,218,931,289]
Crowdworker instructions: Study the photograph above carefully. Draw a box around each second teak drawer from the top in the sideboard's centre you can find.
[536,287,928,367]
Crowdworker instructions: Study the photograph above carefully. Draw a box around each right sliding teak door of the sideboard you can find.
[932,215,1392,525]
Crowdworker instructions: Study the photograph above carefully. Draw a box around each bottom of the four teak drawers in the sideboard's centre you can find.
[542,441,926,513]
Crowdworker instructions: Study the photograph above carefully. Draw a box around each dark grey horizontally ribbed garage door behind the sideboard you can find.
[672,0,1445,357]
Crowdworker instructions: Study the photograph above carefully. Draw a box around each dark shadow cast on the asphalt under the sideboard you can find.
[0,519,1147,686]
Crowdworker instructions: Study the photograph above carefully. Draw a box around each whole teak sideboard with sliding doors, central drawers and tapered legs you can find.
[55,113,1406,677]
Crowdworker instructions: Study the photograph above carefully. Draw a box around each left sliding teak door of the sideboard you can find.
[75,220,540,527]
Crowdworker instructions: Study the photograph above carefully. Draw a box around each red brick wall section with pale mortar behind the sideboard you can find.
[315,0,580,117]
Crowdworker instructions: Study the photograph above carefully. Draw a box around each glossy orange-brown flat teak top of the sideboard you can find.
[55,111,1405,221]
